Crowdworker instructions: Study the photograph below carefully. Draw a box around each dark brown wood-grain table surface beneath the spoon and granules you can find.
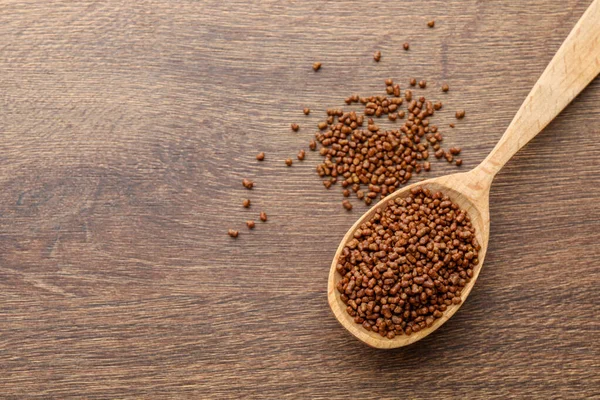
[0,0,600,399]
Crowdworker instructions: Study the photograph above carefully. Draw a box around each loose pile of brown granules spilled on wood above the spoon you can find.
[309,79,462,209]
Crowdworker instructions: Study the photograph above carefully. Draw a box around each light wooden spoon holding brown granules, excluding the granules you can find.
[327,0,600,349]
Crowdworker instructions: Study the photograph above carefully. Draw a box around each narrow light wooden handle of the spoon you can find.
[478,0,600,177]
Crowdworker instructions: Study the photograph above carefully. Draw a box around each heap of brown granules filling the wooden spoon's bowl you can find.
[336,187,481,339]
